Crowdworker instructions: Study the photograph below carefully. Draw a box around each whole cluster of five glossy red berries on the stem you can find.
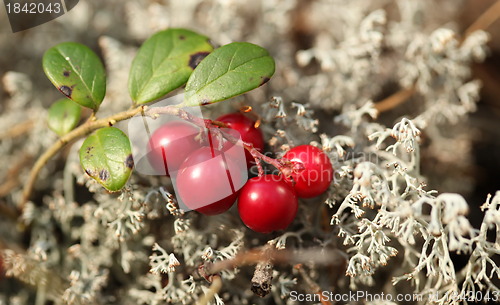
[148,113,333,233]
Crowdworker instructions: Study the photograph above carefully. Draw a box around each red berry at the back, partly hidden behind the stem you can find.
[216,112,264,166]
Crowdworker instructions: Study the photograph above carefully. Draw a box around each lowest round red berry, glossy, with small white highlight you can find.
[238,175,298,233]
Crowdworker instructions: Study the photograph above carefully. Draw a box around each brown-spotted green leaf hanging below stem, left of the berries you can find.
[80,127,134,191]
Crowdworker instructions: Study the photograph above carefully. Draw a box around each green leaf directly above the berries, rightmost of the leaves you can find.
[182,42,274,106]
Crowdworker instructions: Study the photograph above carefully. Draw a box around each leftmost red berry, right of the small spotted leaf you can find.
[148,121,201,176]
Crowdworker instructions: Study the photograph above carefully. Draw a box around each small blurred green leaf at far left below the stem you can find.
[48,98,82,137]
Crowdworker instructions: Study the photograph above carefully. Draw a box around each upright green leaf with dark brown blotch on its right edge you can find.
[128,29,213,104]
